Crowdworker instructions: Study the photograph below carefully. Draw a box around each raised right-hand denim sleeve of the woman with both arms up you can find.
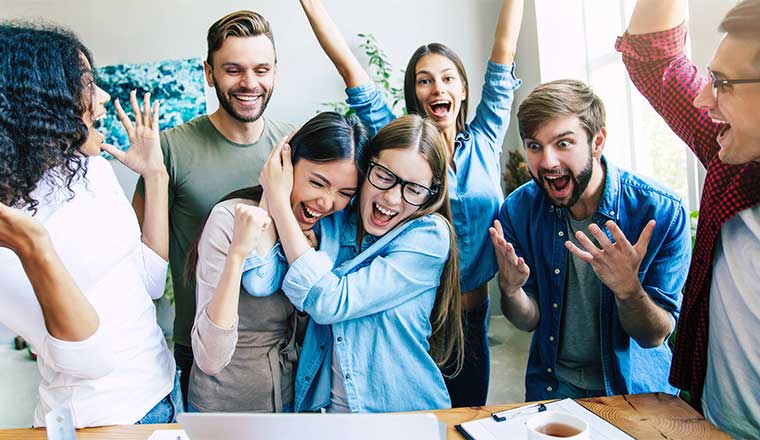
[470,61,522,155]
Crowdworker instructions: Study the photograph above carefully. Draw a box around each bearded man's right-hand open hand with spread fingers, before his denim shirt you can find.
[565,220,655,300]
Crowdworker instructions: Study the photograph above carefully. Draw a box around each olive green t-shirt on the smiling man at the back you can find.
[135,115,294,347]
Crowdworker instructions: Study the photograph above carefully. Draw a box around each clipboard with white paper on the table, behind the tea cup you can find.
[454,399,634,440]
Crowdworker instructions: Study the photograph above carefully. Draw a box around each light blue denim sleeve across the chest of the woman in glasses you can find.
[283,216,450,325]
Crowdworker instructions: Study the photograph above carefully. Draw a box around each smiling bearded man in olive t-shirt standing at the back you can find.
[132,11,293,405]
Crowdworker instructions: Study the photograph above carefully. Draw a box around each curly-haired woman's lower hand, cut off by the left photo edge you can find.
[0,203,49,257]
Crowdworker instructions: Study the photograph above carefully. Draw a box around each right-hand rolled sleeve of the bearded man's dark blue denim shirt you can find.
[641,203,691,320]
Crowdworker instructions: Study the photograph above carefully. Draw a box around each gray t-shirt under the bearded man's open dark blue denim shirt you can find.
[557,210,604,390]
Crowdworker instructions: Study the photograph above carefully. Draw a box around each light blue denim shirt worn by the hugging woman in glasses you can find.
[244,211,451,412]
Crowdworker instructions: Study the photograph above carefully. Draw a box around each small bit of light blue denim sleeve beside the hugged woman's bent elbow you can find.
[241,241,288,296]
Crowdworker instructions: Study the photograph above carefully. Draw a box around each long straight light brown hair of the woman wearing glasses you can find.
[359,115,464,377]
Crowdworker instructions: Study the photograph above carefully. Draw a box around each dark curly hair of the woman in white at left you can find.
[0,22,94,212]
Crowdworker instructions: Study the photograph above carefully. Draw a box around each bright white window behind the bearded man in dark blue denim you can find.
[536,0,700,209]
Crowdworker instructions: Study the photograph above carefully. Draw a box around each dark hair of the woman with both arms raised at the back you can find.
[404,43,470,132]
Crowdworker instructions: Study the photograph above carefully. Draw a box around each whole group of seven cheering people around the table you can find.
[0,0,760,438]
